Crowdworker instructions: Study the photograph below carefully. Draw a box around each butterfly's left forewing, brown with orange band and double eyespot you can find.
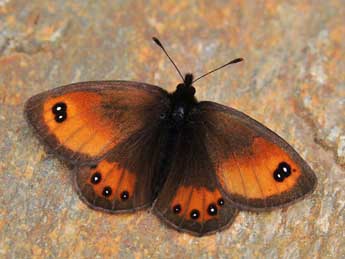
[25,81,168,164]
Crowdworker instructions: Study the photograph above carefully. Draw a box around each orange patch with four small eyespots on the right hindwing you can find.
[170,186,224,223]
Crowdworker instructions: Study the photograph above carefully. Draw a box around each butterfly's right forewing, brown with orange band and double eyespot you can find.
[198,102,317,210]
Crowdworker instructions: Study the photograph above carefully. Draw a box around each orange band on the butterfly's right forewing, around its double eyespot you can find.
[217,137,301,199]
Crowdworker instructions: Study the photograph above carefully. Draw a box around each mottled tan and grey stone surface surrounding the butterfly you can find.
[0,0,345,258]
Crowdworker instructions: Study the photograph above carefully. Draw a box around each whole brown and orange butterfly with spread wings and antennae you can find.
[25,38,317,236]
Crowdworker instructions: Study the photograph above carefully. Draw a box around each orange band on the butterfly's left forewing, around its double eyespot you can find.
[43,92,119,156]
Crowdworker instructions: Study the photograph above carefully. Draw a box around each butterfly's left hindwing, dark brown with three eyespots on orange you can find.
[75,119,168,213]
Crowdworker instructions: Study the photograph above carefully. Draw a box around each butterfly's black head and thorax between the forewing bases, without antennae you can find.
[170,74,198,123]
